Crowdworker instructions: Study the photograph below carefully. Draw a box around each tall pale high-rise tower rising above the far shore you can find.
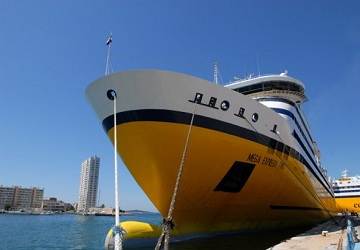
[77,156,100,212]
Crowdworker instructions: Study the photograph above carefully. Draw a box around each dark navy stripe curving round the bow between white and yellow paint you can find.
[102,109,334,197]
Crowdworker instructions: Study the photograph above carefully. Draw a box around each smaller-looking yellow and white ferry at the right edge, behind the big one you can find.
[333,170,360,214]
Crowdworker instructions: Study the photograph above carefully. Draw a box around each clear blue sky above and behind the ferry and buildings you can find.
[0,0,360,210]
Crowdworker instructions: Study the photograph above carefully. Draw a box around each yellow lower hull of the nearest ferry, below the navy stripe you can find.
[108,121,336,234]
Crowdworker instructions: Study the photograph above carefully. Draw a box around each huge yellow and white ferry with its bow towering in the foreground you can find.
[86,70,336,234]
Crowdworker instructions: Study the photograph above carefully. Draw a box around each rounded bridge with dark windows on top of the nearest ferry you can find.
[225,73,307,104]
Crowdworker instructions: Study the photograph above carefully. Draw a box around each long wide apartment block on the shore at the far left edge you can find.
[0,186,44,210]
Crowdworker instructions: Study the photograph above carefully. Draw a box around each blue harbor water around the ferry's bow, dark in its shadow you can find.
[0,214,310,250]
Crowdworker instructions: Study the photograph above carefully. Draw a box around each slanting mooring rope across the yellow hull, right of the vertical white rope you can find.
[155,110,195,250]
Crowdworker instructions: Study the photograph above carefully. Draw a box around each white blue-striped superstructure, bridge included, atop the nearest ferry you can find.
[225,72,329,187]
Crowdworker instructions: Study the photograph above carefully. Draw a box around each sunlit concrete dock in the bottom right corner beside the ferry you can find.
[269,216,360,250]
